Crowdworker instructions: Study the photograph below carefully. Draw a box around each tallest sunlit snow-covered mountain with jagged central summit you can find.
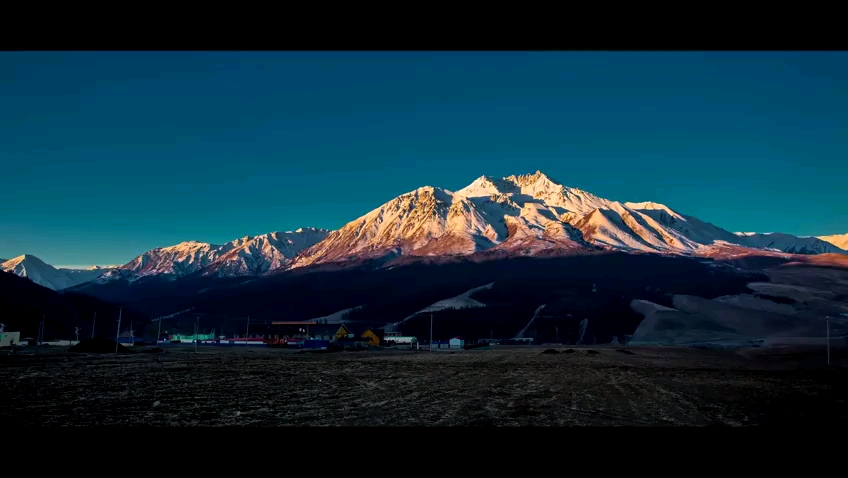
[290,171,776,268]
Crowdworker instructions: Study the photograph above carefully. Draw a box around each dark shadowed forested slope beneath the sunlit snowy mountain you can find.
[68,253,768,342]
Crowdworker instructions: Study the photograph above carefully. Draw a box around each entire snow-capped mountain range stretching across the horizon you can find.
[6,171,848,290]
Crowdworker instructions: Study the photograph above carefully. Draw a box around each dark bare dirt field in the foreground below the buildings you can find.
[0,346,848,426]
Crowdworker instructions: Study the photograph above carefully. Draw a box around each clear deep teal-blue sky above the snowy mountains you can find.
[0,52,848,266]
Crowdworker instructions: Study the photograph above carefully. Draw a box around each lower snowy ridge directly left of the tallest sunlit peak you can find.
[103,228,329,280]
